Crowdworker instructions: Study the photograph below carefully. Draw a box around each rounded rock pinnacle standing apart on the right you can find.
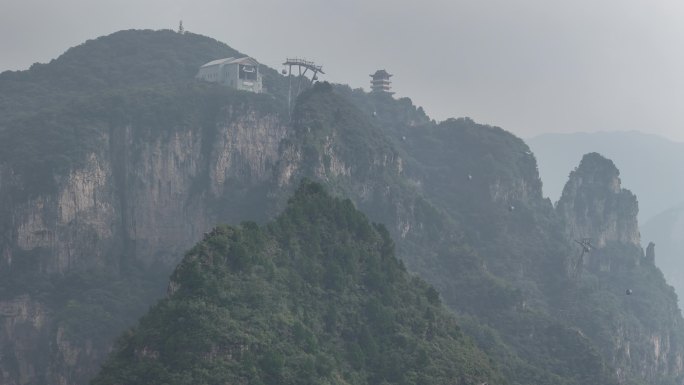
[556,153,640,247]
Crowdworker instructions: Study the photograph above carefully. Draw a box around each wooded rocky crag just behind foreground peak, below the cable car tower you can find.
[274,84,412,243]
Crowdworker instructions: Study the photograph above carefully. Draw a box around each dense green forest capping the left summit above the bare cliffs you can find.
[0,31,286,198]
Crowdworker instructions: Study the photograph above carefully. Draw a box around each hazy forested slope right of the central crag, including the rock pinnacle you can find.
[328,85,682,384]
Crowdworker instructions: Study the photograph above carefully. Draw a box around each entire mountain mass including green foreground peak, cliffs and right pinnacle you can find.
[0,31,684,385]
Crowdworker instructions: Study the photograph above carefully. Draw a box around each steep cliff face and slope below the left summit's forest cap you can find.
[0,87,285,383]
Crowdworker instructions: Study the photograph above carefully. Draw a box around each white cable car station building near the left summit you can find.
[195,56,262,93]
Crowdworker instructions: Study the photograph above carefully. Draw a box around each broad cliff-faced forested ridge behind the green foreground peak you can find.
[0,31,684,385]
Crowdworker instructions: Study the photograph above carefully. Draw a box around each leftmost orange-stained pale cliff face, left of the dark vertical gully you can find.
[6,154,117,273]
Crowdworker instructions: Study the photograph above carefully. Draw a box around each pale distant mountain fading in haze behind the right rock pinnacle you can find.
[528,132,684,308]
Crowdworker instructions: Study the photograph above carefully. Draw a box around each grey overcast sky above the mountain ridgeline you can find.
[0,0,684,141]
